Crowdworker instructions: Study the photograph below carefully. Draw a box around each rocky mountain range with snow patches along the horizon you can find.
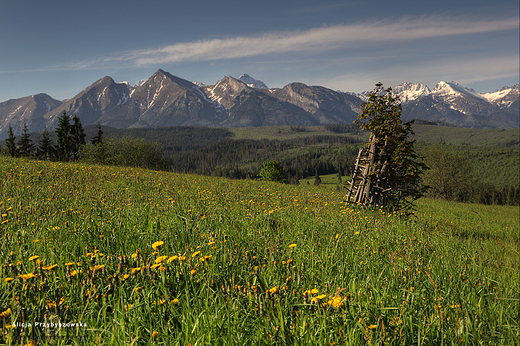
[0,70,520,139]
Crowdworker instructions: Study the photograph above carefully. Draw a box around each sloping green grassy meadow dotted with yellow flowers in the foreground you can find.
[0,156,520,345]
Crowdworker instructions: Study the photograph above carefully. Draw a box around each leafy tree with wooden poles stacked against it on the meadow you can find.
[348,83,427,212]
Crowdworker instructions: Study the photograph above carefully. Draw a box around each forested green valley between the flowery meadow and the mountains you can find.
[2,123,520,205]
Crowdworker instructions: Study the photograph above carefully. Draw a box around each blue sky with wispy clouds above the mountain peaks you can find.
[0,0,519,102]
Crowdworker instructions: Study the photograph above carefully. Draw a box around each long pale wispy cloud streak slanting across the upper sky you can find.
[98,17,519,67]
